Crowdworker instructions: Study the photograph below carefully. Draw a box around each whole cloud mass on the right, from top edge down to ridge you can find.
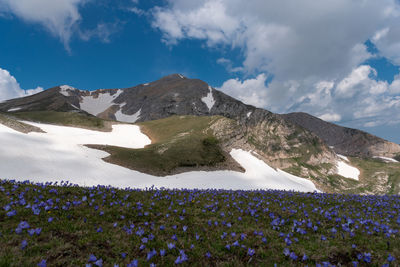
[152,0,400,130]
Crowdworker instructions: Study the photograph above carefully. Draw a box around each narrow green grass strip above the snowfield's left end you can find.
[12,111,105,130]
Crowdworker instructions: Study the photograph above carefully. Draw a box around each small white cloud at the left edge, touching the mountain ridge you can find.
[0,68,43,101]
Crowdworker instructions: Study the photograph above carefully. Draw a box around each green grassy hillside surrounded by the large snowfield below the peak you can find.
[89,116,234,175]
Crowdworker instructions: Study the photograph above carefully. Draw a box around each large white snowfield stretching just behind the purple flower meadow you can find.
[0,122,317,192]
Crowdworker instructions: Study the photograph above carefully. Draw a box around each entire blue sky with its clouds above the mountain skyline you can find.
[0,0,400,143]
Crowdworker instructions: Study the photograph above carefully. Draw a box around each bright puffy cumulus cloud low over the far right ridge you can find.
[282,65,400,127]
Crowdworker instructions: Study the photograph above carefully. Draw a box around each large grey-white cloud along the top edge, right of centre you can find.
[153,0,400,80]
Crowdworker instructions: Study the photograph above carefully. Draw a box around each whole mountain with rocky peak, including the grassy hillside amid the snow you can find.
[0,74,400,193]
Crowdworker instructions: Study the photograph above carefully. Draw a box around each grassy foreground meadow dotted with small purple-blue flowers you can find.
[0,180,400,266]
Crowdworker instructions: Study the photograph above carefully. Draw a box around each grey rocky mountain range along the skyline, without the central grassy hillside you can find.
[0,74,400,193]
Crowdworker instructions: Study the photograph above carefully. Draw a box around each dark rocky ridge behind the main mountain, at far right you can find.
[281,113,400,158]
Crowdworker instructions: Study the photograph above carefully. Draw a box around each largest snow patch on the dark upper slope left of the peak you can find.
[80,90,123,116]
